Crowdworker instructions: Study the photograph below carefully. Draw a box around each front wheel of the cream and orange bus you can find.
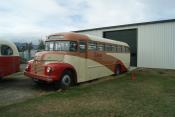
[55,71,73,89]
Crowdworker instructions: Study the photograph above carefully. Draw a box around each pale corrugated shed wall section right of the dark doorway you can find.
[138,23,175,69]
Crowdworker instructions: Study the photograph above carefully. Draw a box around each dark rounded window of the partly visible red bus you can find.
[1,45,13,55]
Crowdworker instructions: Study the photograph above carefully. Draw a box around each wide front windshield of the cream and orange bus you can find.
[45,41,77,52]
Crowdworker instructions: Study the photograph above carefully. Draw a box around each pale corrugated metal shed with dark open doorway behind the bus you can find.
[75,19,175,69]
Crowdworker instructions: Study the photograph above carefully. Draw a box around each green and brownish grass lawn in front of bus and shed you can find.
[0,69,175,117]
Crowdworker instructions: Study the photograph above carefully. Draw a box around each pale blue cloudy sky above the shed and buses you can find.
[0,0,175,43]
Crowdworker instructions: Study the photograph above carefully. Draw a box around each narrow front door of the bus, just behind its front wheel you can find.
[77,40,87,82]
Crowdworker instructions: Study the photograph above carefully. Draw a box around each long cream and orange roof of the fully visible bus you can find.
[46,32,129,46]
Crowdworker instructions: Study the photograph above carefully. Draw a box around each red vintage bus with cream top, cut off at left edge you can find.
[0,39,20,78]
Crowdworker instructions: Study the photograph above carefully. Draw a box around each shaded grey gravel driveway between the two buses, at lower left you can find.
[0,72,54,107]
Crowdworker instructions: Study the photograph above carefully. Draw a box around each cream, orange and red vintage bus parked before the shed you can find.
[24,32,130,87]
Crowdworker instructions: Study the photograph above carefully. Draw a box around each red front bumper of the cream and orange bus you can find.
[24,71,54,83]
